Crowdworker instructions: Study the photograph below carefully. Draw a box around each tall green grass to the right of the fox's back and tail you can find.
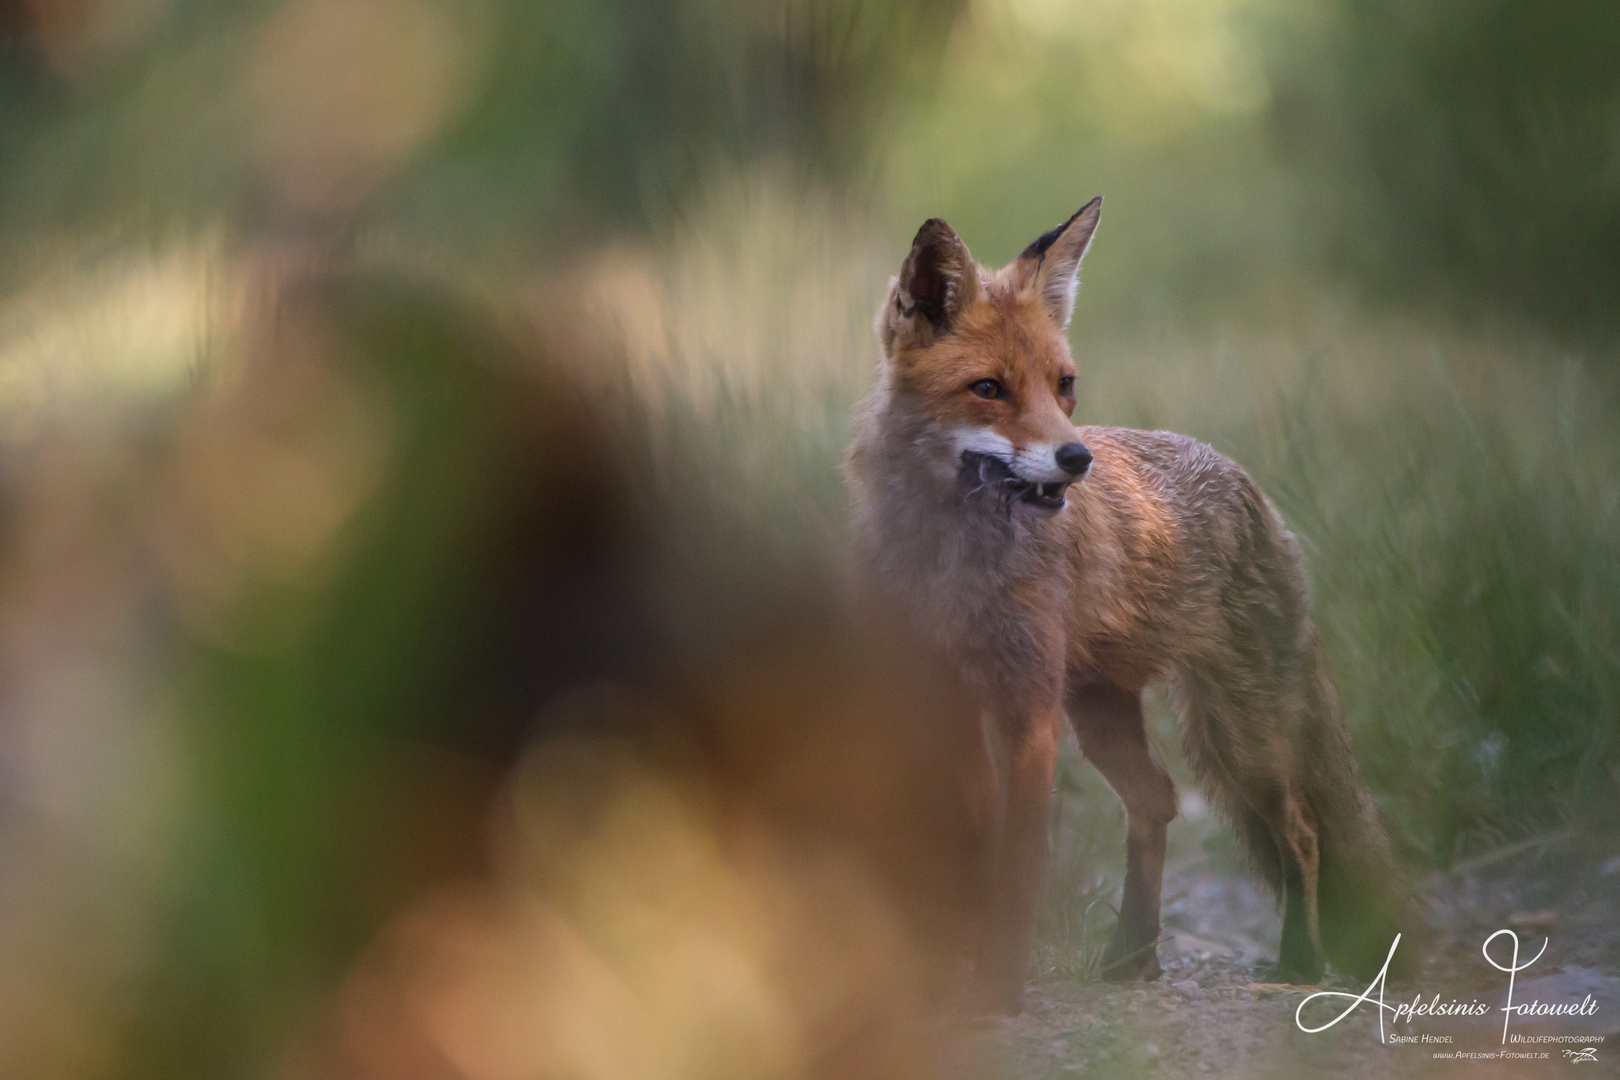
[1277,342,1620,865]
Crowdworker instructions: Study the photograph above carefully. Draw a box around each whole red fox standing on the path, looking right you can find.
[846,198,1421,1012]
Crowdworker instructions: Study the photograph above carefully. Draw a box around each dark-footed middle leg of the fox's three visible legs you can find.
[1068,683,1176,983]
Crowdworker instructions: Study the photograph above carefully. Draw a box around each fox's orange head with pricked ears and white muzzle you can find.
[876,198,1103,515]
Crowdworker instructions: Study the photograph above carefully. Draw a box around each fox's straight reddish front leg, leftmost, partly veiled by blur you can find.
[982,708,1063,1012]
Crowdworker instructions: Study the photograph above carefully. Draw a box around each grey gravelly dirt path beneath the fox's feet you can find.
[982,837,1620,1080]
